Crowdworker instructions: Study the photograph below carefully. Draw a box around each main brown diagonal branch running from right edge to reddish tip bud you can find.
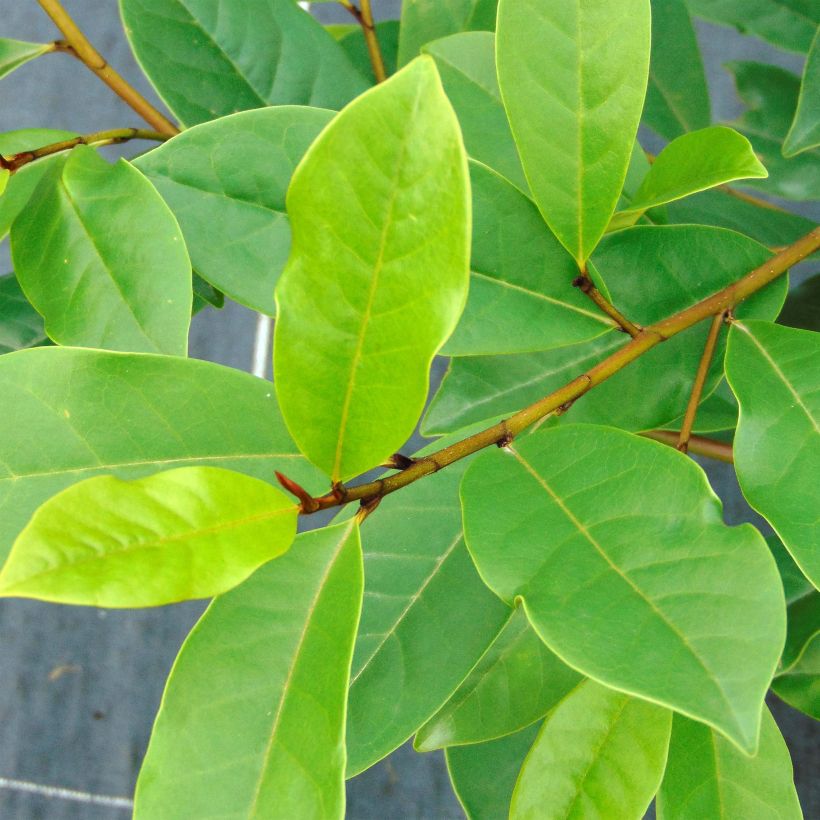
[288,227,820,514]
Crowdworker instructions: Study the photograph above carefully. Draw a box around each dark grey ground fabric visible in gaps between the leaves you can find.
[0,0,820,820]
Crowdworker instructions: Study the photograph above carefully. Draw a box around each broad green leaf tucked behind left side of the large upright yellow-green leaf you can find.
[134,106,333,315]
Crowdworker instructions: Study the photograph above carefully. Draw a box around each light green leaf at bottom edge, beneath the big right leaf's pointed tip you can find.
[656,707,803,820]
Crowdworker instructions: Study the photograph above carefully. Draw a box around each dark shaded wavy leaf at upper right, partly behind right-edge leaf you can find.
[726,62,820,201]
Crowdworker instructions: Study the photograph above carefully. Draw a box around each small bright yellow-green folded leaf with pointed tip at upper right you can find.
[610,125,768,228]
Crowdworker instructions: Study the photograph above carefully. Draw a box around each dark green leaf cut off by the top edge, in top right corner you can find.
[687,0,820,53]
